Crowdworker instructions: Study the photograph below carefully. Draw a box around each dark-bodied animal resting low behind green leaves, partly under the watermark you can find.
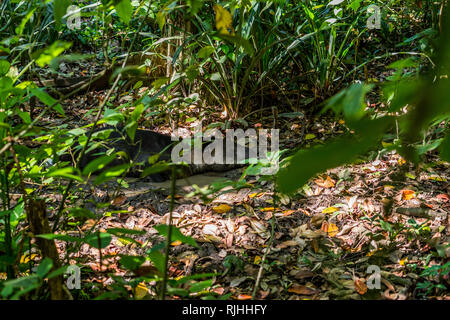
[66,127,249,182]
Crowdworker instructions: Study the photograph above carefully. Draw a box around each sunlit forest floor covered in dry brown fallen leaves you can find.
[29,58,450,300]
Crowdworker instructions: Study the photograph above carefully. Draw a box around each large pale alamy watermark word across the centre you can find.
[171,122,279,175]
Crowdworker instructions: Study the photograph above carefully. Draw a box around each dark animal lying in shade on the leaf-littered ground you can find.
[60,126,250,182]
